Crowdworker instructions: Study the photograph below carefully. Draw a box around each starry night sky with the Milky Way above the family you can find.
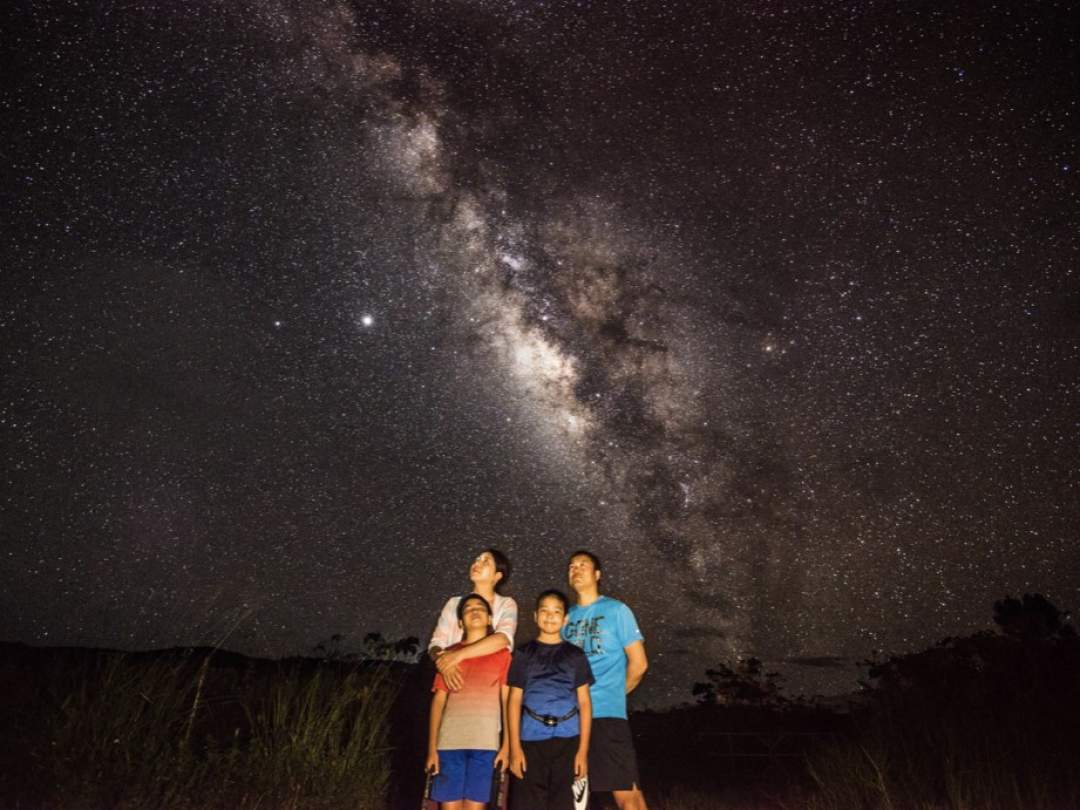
[0,0,1080,703]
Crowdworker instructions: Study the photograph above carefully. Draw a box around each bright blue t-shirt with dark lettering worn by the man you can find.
[563,596,645,719]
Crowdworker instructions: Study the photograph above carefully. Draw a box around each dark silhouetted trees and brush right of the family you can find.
[643,594,1080,810]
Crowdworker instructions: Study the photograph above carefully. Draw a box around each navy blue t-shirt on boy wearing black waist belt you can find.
[507,640,593,742]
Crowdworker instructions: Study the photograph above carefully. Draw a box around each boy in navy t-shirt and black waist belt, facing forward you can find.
[507,590,593,810]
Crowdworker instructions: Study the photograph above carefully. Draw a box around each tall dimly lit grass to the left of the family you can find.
[17,653,396,810]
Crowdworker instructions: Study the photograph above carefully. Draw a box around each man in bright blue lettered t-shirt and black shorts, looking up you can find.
[563,551,649,810]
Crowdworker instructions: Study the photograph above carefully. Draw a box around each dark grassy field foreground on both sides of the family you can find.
[0,632,1080,810]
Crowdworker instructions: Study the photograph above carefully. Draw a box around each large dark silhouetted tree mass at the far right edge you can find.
[813,594,1080,808]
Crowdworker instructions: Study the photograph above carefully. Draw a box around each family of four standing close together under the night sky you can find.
[426,549,648,810]
